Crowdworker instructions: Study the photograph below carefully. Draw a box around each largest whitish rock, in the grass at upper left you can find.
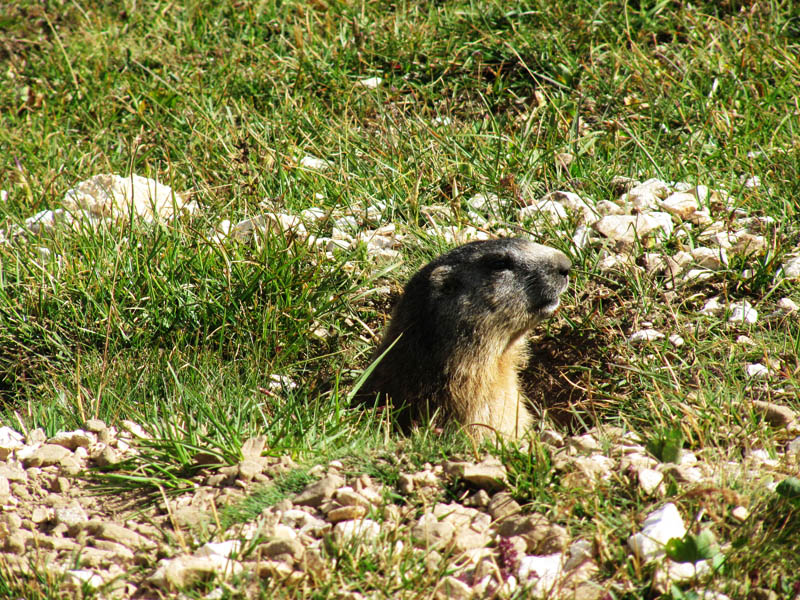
[64,173,192,223]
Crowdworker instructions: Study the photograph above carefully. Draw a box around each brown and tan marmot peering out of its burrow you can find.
[357,238,572,437]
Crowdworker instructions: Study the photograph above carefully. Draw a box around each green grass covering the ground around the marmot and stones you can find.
[0,0,800,600]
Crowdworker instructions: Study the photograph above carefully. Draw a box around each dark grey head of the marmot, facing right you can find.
[416,238,572,337]
